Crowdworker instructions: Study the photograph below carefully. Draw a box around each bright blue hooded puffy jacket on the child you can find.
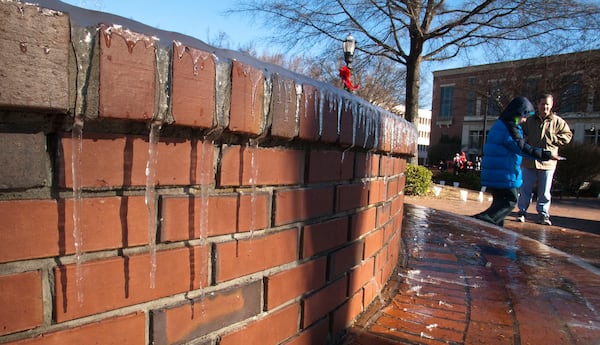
[481,97,552,189]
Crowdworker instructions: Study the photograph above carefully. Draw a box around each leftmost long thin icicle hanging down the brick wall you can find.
[71,117,83,305]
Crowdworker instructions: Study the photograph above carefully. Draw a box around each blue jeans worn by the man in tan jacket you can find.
[517,168,554,217]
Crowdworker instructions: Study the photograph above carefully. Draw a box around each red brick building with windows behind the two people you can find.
[430,50,600,160]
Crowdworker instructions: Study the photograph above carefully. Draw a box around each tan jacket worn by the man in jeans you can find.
[521,113,573,170]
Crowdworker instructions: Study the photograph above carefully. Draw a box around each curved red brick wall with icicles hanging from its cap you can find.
[0,1,416,344]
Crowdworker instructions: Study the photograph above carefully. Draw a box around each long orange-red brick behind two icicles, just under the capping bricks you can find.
[59,135,214,187]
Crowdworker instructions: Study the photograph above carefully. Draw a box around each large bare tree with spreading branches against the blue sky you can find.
[234,0,600,122]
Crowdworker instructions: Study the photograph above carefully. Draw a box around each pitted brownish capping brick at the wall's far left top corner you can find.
[0,2,70,112]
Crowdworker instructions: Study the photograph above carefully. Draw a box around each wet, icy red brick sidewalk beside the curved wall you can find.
[344,189,600,345]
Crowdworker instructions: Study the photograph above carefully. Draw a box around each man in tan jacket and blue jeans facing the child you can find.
[517,93,573,225]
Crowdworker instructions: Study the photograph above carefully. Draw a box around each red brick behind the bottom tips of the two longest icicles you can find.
[54,248,207,322]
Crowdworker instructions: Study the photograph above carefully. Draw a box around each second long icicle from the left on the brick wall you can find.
[145,121,162,289]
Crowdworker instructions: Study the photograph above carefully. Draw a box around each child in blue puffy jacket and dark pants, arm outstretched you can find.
[473,97,564,226]
